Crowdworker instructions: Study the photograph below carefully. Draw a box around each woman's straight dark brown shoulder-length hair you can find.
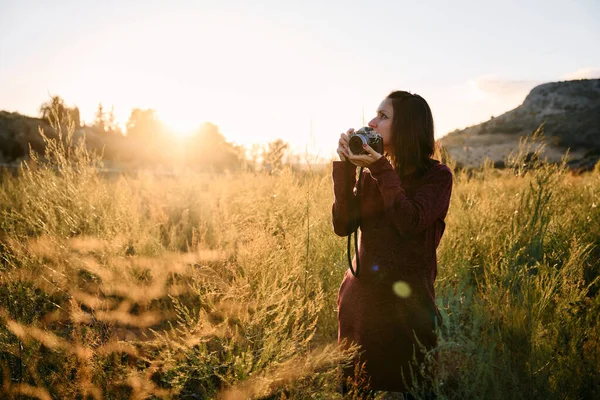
[387,90,435,175]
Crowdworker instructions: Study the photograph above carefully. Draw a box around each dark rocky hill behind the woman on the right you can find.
[441,79,600,169]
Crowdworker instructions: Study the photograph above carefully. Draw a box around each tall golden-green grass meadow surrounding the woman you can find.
[0,123,600,400]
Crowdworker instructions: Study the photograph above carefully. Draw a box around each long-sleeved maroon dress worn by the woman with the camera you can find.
[332,157,452,392]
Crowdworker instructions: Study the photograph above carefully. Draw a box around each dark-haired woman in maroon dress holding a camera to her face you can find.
[332,91,452,392]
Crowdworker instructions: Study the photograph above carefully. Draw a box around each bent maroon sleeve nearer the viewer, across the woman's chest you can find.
[369,157,452,236]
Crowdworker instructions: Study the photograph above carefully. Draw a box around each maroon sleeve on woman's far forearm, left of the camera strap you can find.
[331,161,358,236]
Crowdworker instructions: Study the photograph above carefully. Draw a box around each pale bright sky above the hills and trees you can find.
[0,0,600,156]
